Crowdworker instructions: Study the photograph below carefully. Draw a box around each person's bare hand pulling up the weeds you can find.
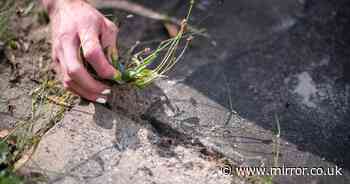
[42,0,118,103]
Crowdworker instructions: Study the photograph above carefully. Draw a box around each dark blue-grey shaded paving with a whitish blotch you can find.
[178,0,350,169]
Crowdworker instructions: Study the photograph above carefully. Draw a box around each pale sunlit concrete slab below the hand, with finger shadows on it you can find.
[24,104,231,184]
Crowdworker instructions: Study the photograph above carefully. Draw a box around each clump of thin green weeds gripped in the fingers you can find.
[107,0,194,89]
